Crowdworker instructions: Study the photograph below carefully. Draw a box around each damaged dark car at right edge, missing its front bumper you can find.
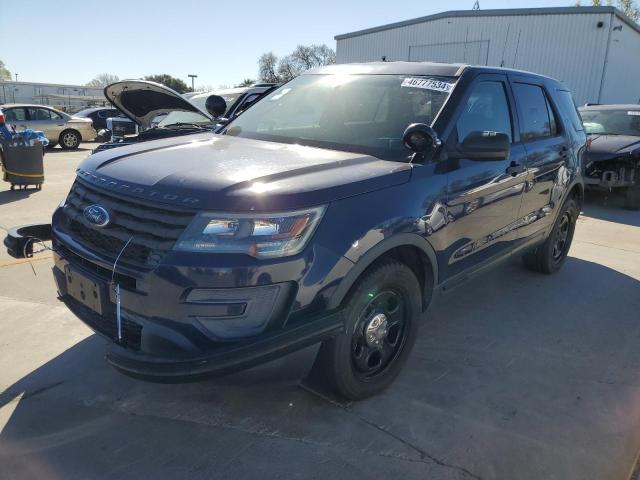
[579,105,640,210]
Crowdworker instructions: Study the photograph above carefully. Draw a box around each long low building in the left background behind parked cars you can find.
[0,81,106,111]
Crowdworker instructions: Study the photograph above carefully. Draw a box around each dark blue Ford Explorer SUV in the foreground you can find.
[52,62,585,399]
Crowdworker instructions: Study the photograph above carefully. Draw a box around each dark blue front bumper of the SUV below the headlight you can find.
[53,217,345,382]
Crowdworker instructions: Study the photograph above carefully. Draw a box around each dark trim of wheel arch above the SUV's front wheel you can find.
[329,233,438,311]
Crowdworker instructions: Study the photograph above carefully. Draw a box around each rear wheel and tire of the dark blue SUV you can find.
[522,198,580,274]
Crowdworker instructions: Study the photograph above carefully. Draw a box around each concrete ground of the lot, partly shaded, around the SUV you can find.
[0,143,640,480]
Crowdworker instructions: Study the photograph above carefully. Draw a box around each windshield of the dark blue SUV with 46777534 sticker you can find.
[226,75,455,160]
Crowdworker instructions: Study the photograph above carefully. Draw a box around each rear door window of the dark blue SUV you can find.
[513,83,556,142]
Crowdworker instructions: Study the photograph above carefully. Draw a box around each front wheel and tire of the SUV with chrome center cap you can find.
[311,260,422,400]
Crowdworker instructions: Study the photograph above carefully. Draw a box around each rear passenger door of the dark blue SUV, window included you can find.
[512,77,570,248]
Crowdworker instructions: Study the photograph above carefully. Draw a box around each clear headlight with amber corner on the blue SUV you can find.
[175,206,326,258]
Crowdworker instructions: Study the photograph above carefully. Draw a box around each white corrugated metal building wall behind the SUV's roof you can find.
[336,12,640,103]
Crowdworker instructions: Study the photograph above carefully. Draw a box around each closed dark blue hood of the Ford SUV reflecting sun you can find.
[77,133,411,211]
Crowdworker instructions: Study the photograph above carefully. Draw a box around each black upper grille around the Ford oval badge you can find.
[64,180,193,269]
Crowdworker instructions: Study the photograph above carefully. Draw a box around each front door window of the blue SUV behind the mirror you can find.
[456,81,513,142]
